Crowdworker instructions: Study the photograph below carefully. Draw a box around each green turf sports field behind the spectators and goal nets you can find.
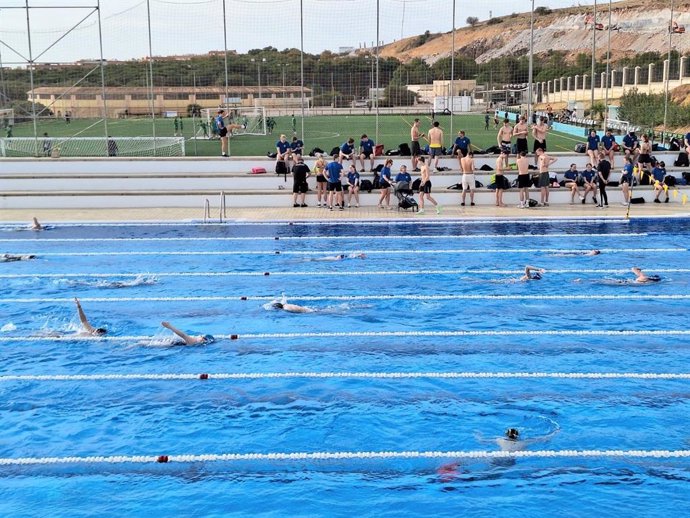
[2,114,584,156]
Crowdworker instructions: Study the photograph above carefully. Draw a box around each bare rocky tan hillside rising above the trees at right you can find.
[381,0,690,63]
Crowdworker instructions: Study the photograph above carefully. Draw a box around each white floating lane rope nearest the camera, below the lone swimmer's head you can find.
[0,450,690,466]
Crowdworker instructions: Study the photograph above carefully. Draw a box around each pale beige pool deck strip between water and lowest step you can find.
[0,200,690,223]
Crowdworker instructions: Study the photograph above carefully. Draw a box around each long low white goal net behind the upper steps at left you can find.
[0,136,185,157]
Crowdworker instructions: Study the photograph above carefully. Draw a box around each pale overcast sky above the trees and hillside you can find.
[0,0,608,66]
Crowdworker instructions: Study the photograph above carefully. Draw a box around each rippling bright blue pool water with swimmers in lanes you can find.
[0,219,690,517]
